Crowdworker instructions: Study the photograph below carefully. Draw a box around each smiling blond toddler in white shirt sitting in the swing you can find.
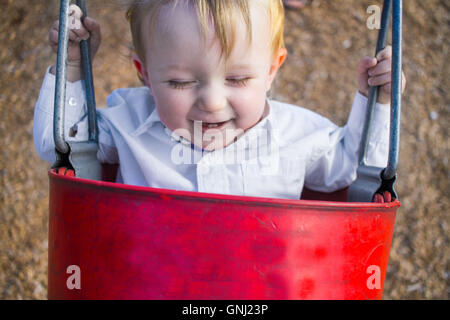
[34,0,404,199]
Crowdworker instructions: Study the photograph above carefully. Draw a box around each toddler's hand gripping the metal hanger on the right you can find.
[358,46,406,104]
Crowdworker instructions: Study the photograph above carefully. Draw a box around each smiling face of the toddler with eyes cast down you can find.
[135,2,286,150]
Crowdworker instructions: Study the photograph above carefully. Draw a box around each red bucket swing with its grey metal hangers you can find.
[48,0,401,299]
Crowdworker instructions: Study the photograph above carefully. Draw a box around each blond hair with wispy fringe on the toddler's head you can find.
[126,0,284,62]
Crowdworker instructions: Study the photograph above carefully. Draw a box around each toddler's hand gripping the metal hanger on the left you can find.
[48,5,101,82]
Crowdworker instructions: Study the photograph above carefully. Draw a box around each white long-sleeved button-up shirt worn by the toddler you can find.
[33,71,389,199]
